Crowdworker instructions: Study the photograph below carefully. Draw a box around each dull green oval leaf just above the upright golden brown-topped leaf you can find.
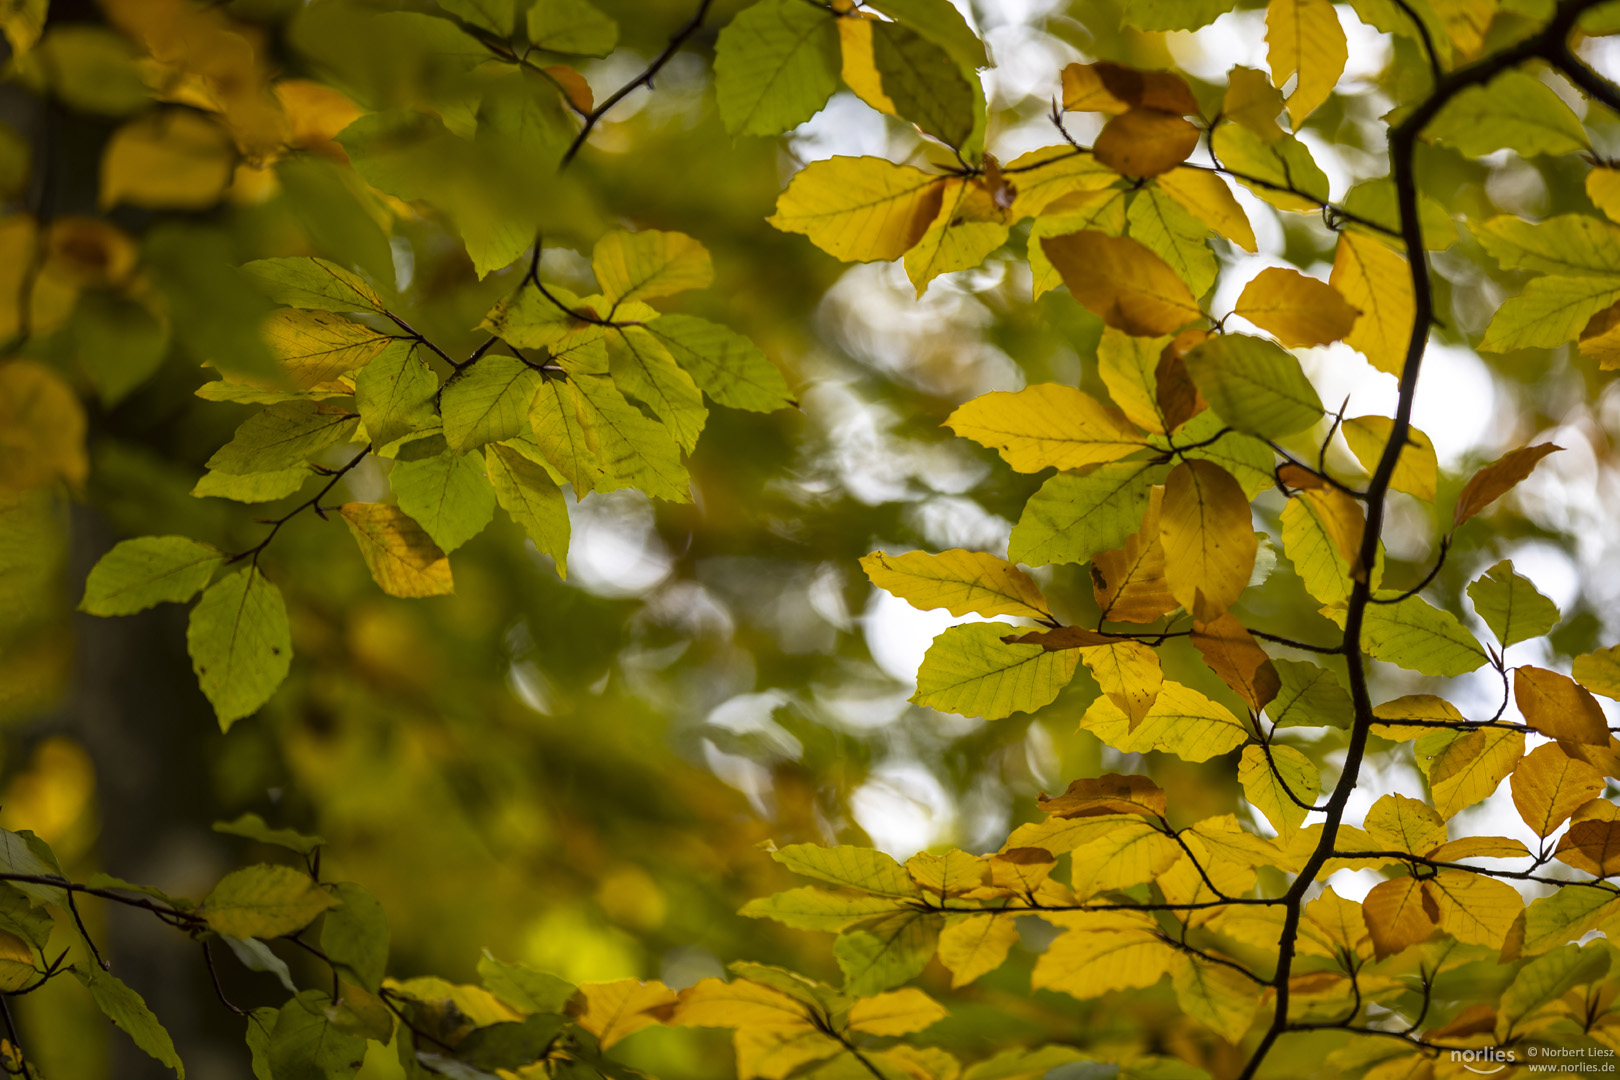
[1186,334,1322,439]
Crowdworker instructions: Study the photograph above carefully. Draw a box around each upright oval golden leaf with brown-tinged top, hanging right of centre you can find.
[1158,461,1259,620]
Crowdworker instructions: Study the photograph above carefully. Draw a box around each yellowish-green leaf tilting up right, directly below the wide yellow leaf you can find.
[1008,460,1168,567]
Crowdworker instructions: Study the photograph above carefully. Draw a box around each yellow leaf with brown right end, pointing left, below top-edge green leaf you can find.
[766,156,944,262]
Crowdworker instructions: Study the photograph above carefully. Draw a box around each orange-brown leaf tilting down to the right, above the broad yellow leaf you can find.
[1040,230,1202,337]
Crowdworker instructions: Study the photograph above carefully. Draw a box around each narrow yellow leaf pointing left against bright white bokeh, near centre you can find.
[860,549,1051,619]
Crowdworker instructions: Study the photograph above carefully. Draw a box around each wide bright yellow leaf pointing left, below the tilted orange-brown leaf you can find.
[944,382,1149,473]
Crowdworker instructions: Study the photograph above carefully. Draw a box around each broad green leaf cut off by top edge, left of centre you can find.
[714,0,841,134]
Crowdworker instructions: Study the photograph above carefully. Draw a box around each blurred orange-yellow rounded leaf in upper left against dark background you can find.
[100,108,237,210]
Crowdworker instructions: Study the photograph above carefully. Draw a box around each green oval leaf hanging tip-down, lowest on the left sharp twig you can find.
[186,567,293,731]
